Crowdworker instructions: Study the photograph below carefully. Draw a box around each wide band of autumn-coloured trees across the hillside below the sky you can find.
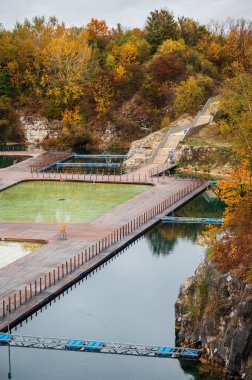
[0,9,252,145]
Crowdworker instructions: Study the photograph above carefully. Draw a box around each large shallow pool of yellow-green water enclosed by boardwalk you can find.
[0,181,150,223]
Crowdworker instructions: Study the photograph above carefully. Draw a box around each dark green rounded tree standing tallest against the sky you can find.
[145,9,177,52]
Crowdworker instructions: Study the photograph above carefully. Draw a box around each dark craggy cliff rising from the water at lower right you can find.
[175,261,252,380]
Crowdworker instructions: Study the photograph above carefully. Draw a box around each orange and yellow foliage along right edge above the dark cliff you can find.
[200,74,252,282]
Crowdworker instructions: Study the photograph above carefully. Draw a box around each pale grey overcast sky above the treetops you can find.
[0,0,252,29]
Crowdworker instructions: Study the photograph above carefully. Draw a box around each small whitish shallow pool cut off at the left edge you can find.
[0,241,43,268]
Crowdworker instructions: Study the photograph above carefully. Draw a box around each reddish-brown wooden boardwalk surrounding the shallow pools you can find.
[0,151,208,331]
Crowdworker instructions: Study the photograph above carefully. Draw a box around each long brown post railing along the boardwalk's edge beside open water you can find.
[0,180,204,321]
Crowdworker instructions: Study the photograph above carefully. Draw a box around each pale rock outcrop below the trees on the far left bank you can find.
[20,115,62,145]
